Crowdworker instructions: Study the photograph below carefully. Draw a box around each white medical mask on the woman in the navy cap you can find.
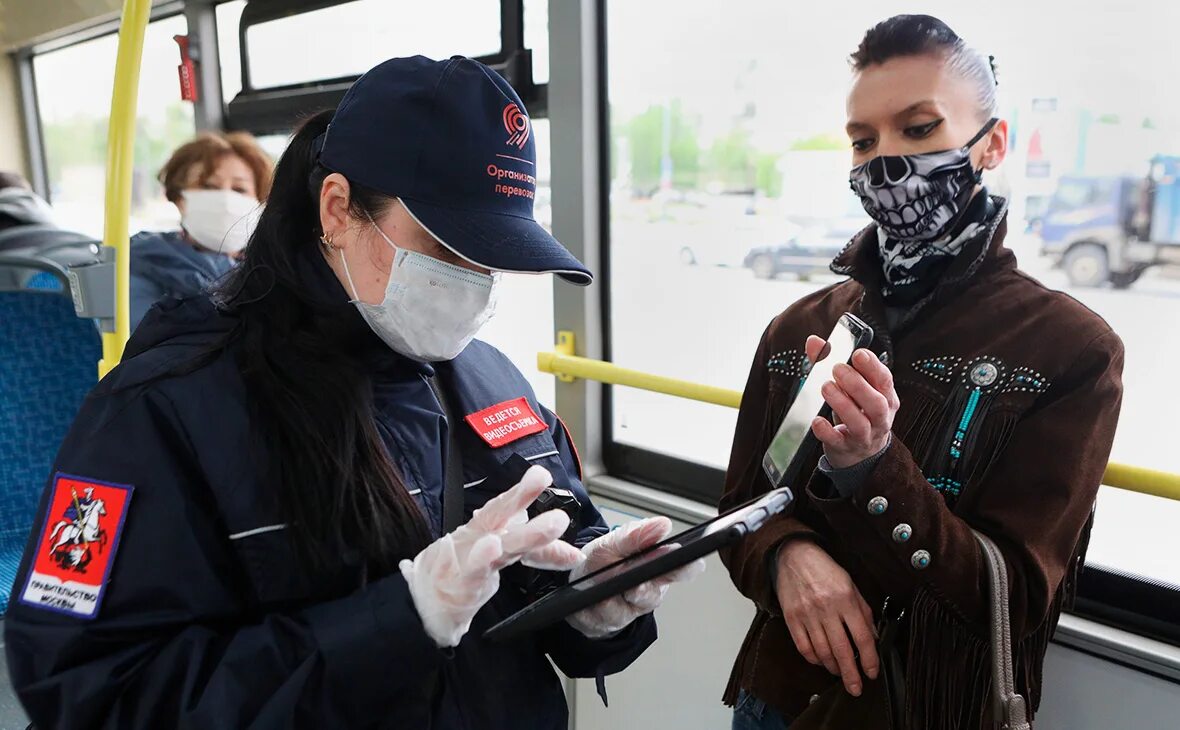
[340,221,499,362]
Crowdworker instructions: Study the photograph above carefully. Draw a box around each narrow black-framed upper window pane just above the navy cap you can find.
[239,0,500,88]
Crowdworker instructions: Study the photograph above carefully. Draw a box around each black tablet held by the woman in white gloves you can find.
[484,487,793,642]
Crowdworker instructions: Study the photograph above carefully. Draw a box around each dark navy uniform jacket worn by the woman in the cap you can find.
[5,254,655,730]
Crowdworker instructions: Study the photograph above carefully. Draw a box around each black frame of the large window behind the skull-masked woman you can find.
[595,0,1180,646]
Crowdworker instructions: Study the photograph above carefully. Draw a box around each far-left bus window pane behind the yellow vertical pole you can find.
[33,15,194,238]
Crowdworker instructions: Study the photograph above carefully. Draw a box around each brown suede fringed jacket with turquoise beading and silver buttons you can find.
[721,199,1123,730]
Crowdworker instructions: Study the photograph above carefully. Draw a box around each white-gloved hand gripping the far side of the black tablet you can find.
[565,517,704,639]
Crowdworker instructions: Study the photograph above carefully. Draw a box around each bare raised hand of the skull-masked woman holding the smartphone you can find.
[806,335,902,469]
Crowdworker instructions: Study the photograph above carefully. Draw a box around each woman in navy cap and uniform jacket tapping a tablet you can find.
[5,58,699,730]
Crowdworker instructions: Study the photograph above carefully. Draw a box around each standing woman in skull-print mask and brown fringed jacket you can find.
[721,15,1123,730]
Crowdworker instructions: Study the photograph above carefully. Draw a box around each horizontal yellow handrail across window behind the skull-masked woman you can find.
[537,333,1180,500]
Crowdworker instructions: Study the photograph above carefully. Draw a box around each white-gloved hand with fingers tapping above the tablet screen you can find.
[398,466,585,647]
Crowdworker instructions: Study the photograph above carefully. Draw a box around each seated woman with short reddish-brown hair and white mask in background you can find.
[131,132,274,329]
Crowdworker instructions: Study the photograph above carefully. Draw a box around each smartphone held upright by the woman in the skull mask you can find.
[762,313,873,487]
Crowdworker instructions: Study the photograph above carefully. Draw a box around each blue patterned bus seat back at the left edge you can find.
[0,289,101,613]
